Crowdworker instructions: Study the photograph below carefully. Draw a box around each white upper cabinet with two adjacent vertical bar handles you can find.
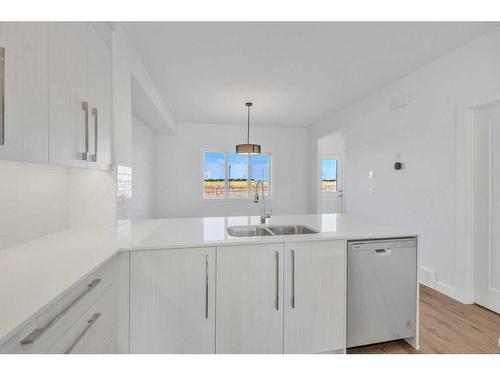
[49,22,112,169]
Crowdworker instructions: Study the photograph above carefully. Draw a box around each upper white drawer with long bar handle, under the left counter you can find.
[0,262,113,354]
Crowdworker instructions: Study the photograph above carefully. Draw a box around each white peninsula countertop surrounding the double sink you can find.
[121,214,415,251]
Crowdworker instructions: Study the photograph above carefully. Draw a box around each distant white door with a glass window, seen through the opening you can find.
[318,154,344,214]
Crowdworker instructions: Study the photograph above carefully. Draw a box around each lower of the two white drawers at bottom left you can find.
[49,287,114,354]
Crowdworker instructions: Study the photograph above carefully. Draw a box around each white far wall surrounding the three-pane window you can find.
[155,123,308,217]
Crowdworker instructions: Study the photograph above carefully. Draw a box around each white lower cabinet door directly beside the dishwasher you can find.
[284,241,346,353]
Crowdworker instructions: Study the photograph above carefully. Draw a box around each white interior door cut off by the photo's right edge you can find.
[474,104,500,313]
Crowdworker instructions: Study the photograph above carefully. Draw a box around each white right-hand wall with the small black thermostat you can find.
[310,29,500,299]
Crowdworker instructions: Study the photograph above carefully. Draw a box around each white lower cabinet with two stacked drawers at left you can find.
[0,260,116,354]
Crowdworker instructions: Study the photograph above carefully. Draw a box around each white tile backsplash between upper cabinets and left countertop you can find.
[0,160,116,249]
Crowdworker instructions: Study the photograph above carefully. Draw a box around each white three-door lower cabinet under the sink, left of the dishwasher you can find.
[130,240,346,353]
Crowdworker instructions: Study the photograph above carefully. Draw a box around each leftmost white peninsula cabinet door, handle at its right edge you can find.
[130,248,215,353]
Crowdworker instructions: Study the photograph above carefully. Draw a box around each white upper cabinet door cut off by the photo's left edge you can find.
[0,22,49,163]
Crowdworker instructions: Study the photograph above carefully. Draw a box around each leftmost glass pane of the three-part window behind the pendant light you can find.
[203,152,226,199]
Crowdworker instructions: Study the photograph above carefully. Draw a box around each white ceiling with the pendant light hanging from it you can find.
[124,22,498,126]
